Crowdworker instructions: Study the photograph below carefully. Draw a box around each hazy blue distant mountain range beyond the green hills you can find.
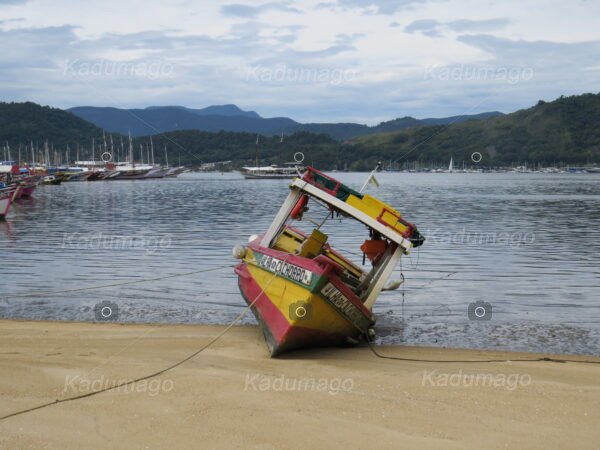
[69,105,502,141]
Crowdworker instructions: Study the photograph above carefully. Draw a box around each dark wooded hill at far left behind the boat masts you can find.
[0,102,102,151]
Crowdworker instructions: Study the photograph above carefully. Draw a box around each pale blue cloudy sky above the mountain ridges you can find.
[0,0,600,124]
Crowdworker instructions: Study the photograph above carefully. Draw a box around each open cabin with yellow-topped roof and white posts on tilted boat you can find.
[260,167,424,310]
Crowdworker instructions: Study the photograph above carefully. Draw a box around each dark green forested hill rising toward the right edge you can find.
[349,94,600,166]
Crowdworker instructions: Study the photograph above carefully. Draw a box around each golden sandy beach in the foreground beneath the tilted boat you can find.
[0,321,600,449]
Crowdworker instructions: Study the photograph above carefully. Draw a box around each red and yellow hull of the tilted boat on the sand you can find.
[235,249,374,356]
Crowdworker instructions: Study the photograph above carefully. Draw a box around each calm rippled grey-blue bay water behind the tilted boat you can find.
[0,173,600,355]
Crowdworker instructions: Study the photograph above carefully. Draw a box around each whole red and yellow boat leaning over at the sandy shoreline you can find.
[233,167,425,356]
